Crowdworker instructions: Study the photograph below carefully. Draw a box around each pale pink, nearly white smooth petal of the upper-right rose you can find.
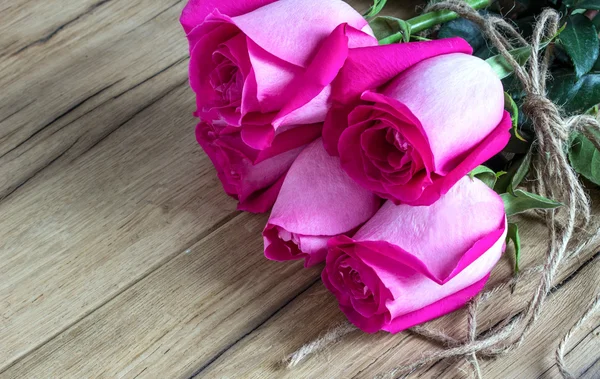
[382,53,504,175]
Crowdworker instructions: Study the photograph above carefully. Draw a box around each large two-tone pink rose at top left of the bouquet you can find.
[180,0,377,150]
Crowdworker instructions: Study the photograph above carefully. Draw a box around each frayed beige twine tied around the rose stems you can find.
[287,0,600,379]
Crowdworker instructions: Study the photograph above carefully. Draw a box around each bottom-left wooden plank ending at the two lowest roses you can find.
[0,213,319,378]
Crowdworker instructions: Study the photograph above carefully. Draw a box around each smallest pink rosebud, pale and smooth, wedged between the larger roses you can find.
[263,139,381,267]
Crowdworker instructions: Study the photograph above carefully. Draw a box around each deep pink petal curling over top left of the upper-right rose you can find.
[323,38,472,155]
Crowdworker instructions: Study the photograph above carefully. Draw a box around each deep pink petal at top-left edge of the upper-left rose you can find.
[179,0,275,33]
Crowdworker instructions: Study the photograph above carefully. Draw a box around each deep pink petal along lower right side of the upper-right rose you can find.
[411,112,512,205]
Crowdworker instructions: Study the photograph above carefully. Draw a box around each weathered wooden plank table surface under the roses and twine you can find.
[0,0,600,378]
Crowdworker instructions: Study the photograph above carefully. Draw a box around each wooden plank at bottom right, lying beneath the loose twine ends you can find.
[195,209,600,378]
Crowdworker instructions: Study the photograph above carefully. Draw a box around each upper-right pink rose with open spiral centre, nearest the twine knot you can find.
[323,38,511,205]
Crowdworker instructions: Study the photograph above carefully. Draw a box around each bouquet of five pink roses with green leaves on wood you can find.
[181,0,600,342]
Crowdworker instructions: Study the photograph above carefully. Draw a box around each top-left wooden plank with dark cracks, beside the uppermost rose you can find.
[0,0,188,199]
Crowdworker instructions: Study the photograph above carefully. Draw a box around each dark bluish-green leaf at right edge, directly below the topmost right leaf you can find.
[548,72,600,114]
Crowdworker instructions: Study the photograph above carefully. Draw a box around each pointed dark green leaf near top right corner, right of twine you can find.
[559,14,599,78]
